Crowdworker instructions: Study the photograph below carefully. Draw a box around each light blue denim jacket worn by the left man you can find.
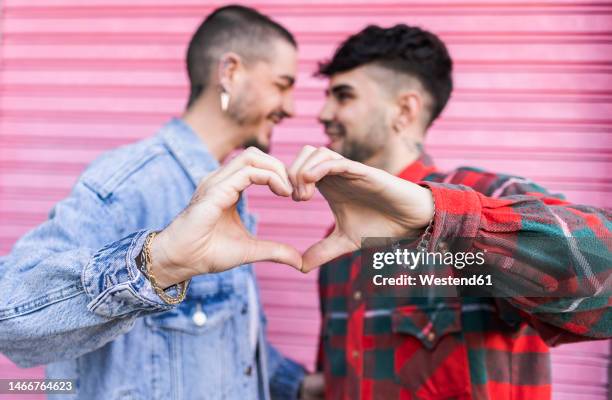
[0,119,304,400]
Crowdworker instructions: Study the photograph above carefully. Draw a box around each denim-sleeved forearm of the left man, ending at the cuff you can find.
[0,228,175,366]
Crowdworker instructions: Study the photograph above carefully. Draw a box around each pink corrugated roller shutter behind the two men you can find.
[0,0,612,399]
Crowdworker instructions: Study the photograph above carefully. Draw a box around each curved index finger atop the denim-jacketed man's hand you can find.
[209,147,292,188]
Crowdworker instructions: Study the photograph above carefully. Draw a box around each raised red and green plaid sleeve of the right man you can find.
[421,173,612,345]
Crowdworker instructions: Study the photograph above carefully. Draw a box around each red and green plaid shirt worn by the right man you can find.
[318,154,612,400]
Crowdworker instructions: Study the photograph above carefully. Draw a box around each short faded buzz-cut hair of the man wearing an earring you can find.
[187,5,297,108]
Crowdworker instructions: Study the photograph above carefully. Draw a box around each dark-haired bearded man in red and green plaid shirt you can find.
[306,25,612,400]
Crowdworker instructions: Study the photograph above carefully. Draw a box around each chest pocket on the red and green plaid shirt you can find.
[391,303,470,399]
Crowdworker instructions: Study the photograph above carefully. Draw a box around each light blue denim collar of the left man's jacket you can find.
[159,118,219,186]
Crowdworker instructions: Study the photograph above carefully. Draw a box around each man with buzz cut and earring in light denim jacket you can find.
[0,6,316,400]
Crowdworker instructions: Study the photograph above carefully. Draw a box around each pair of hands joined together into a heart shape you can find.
[151,146,433,287]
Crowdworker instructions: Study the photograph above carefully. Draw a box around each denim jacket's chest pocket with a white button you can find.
[146,296,248,399]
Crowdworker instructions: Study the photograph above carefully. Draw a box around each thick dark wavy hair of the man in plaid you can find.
[317,24,453,126]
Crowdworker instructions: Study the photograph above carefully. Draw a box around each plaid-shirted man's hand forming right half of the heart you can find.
[289,146,434,272]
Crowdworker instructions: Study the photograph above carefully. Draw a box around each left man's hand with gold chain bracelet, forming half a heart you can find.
[151,147,302,288]
